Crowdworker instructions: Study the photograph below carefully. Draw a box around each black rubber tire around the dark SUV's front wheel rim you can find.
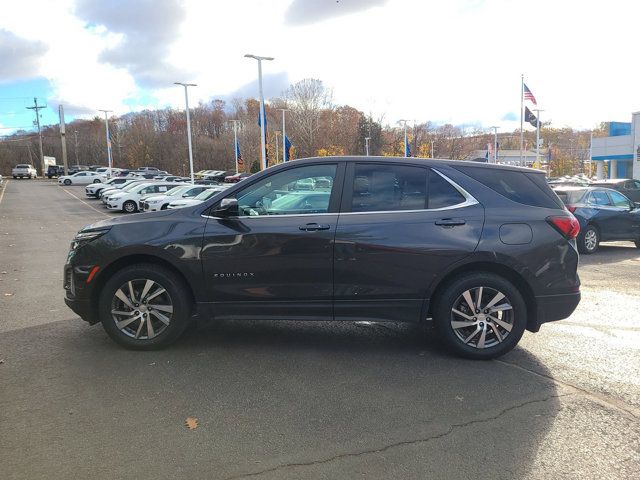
[98,263,192,350]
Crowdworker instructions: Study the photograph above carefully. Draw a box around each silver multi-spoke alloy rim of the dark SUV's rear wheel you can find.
[450,287,514,349]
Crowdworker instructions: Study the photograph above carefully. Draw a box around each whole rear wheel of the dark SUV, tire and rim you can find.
[433,272,527,359]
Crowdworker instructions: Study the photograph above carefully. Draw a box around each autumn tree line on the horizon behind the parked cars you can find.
[0,79,606,175]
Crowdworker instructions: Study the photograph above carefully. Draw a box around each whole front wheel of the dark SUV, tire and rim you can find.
[99,264,191,350]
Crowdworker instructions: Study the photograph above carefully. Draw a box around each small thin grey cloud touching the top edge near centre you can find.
[285,0,387,26]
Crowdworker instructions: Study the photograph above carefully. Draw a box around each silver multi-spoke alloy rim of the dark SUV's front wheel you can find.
[111,279,173,340]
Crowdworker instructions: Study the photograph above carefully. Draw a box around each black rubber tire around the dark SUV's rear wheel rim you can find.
[433,272,527,360]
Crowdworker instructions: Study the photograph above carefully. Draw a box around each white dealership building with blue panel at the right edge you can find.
[591,112,640,179]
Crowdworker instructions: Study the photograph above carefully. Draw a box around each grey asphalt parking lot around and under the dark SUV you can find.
[0,180,640,479]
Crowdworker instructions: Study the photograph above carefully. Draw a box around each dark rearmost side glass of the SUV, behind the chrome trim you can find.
[456,166,563,208]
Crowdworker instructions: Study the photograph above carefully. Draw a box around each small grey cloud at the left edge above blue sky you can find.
[0,29,47,83]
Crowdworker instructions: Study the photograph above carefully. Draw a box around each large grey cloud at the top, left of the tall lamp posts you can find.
[76,0,190,88]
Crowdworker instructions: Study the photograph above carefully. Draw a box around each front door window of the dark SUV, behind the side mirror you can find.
[236,164,337,216]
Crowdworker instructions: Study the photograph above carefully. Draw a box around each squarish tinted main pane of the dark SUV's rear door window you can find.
[351,163,427,212]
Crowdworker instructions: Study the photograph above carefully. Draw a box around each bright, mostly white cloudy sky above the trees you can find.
[0,0,640,135]
